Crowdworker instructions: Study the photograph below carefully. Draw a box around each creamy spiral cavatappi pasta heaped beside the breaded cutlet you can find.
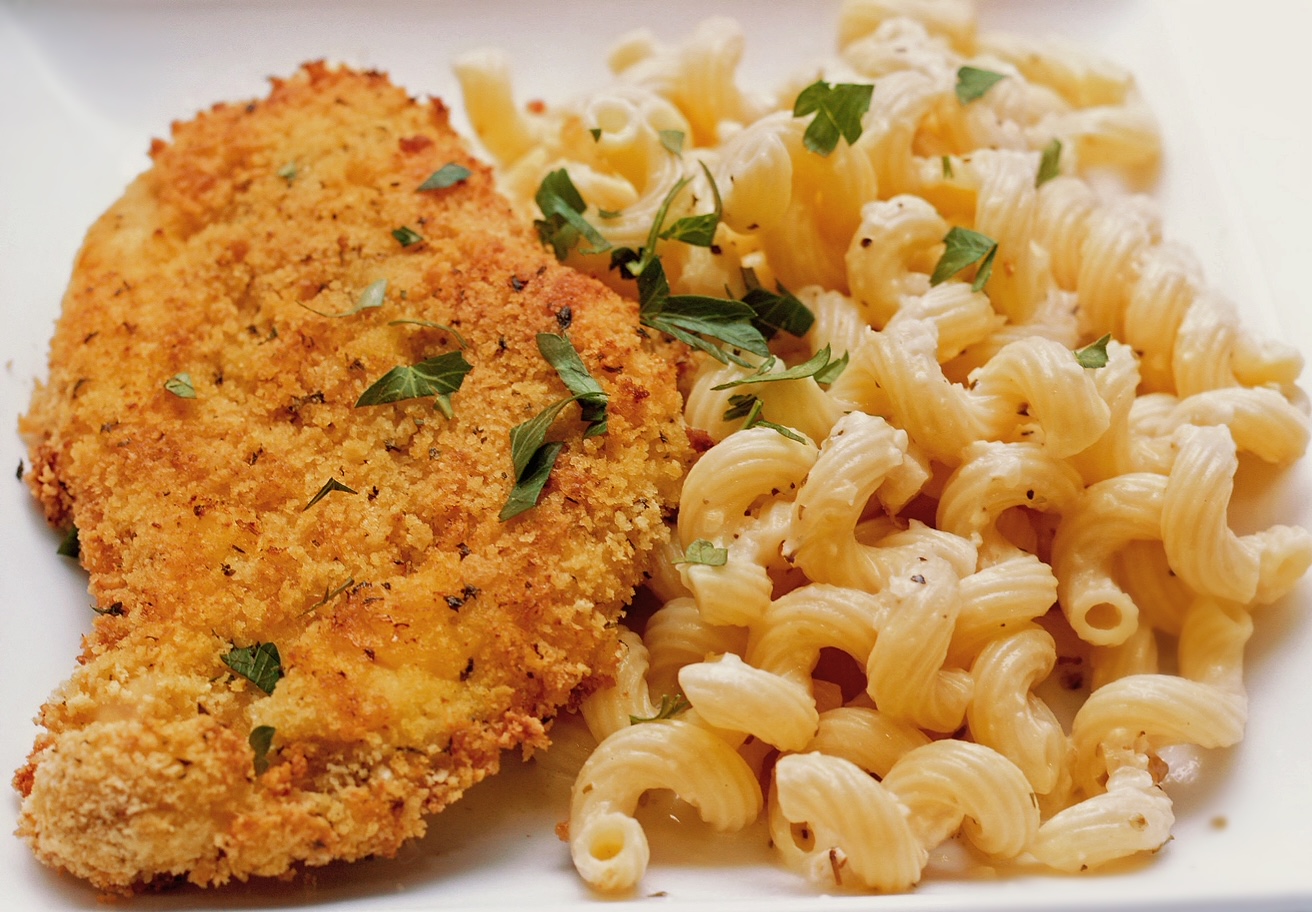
[458,0,1312,891]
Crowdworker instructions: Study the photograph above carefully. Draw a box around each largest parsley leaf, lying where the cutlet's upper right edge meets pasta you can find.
[638,259,770,366]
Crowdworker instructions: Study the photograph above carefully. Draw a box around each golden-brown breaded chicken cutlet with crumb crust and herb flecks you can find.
[14,64,689,891]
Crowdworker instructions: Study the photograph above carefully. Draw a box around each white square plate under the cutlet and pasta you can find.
[0,0,1312,912]
